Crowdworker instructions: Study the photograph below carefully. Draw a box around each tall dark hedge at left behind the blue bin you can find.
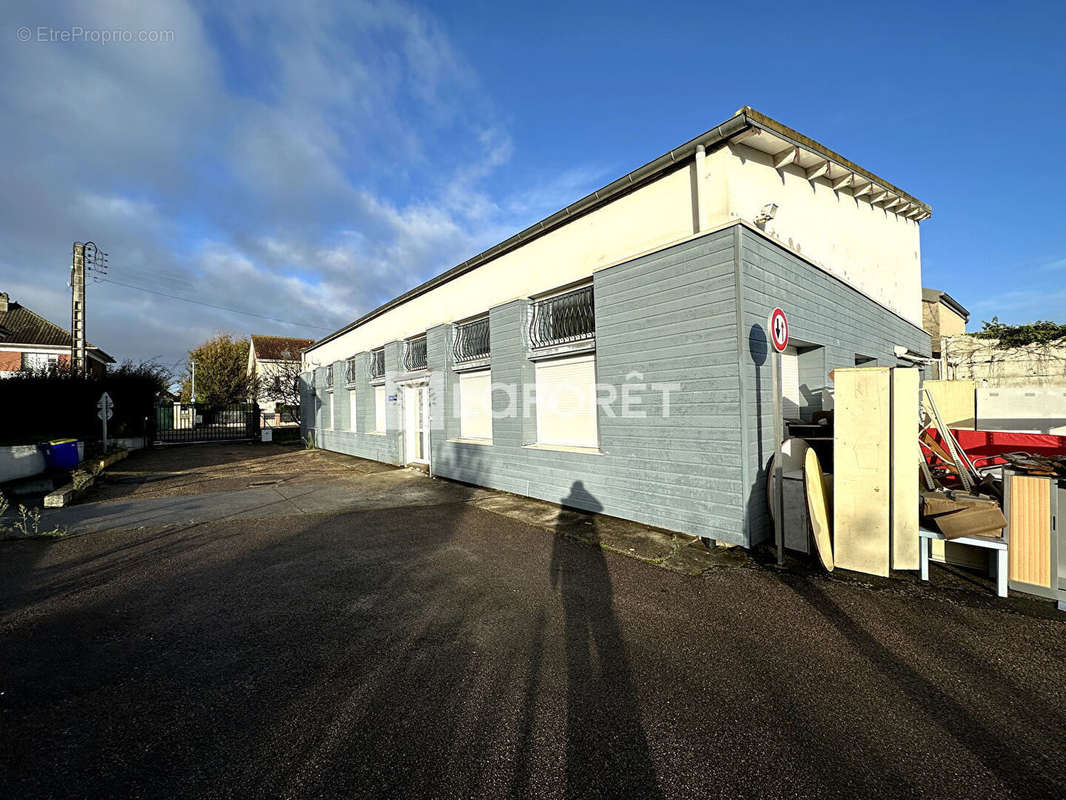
[0,364,169,445]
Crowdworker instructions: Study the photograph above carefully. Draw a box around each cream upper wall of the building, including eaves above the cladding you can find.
[305,109,930,367]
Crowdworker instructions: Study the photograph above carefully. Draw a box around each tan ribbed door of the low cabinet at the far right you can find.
[1007,475,1051,588]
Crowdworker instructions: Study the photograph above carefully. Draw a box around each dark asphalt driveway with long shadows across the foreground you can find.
[0,448,1066,798]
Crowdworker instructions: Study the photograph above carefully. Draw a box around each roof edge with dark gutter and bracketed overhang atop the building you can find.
[309,106,933,353]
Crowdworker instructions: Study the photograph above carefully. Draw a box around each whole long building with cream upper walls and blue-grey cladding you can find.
[302,108,931,546]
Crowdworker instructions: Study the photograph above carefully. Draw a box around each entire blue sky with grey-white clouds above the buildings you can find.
[0,0,1066,365]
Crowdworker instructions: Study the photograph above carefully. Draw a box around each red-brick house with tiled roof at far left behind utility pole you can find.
[0,292,115,378]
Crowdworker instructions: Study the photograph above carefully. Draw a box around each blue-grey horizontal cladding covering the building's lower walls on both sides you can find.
[304,225,928,545]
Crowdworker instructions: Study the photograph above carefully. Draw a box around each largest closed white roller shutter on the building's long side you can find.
[536,355,599,447]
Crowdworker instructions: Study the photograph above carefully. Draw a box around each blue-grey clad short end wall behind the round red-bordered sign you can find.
[733,227,930,544]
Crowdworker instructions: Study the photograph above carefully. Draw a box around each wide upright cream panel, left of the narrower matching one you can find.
[833,367,891,577]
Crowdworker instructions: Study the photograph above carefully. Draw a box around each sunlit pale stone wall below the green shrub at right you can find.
[941,335,1066,389]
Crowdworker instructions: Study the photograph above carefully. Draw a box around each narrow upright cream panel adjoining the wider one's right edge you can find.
[890,367,920,570]
